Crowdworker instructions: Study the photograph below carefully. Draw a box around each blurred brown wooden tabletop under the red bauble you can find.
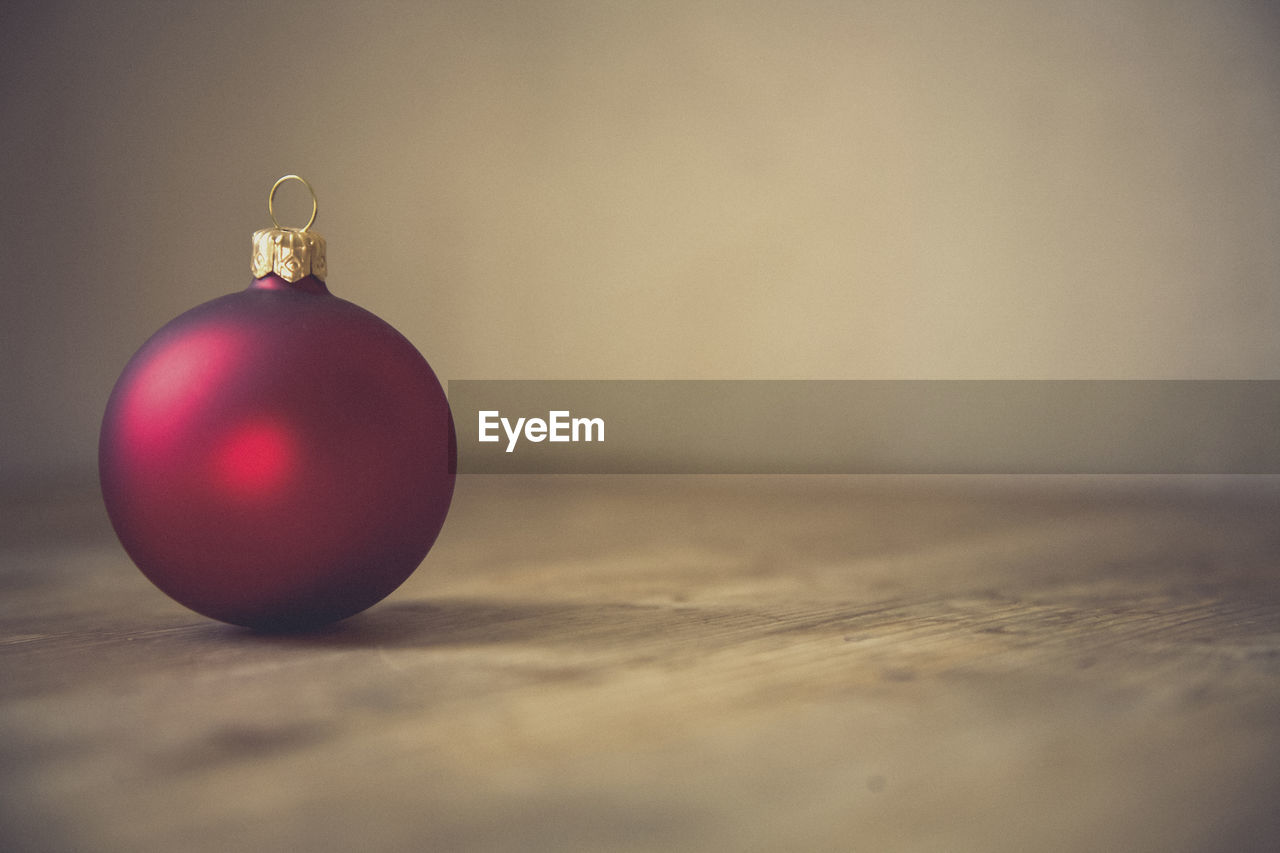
[0,476,1280,853]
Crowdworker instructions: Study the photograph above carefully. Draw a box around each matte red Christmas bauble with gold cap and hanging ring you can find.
[99,175,456,629]
